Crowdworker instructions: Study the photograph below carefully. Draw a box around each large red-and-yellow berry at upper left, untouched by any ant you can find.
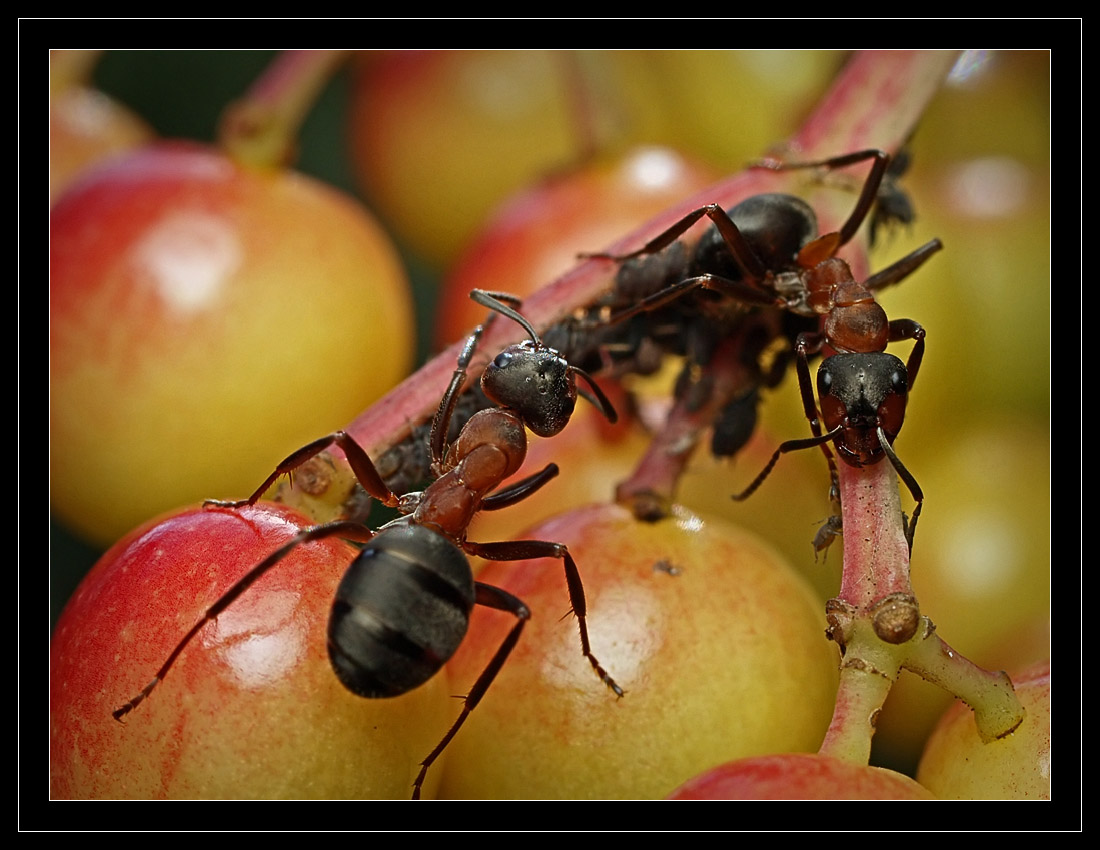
[50,144,414,545]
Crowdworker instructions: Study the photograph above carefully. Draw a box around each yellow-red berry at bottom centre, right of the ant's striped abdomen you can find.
[440,501,836,799]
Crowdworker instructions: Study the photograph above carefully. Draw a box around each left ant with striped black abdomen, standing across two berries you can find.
[113,289,624,799]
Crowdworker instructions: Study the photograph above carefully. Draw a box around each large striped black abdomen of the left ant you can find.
[328,526,475,698]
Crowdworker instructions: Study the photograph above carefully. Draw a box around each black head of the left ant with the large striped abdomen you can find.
[482,340,576,437]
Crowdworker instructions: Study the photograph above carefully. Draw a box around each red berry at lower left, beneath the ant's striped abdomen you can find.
[50,503,453,799]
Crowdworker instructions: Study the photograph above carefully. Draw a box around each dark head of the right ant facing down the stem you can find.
[817,352,909,466]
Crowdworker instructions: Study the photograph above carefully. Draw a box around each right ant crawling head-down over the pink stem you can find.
[587,150,943,551]
